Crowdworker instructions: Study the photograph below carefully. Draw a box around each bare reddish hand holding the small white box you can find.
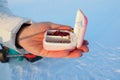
[18,22,88,58]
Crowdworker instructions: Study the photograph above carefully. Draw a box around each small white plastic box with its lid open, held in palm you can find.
[43,10,87,51]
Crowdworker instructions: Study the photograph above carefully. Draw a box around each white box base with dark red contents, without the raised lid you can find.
[43,30,76,50]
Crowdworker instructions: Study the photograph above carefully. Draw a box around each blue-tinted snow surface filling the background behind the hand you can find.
[0,0,120,80]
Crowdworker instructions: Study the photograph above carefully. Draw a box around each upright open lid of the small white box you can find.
[74,9,87,47]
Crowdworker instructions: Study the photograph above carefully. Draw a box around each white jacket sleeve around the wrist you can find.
[0,0,31,52]
